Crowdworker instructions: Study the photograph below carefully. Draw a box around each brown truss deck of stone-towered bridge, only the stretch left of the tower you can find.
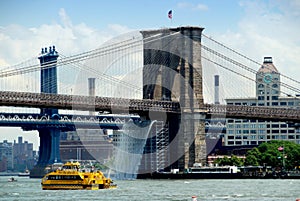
[0,91,180,113]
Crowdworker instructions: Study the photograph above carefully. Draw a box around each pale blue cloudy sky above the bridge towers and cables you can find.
[0,0,300,149]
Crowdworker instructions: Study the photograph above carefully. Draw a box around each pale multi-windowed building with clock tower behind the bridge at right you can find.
[224,57,300,146]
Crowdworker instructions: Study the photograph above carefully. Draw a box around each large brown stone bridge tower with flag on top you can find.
[141,27,206,170]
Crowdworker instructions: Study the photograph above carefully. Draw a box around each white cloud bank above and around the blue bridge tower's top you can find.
[0,9,130,68]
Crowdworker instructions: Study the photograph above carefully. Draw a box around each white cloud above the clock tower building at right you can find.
[210,0,300,96]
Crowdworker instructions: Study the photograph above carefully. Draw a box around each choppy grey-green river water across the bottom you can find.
[0,176,300,201]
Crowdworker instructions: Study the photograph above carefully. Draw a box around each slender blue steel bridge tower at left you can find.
[30,46,61,177]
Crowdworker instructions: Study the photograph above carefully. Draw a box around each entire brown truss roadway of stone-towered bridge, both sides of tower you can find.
[0,91,300,123]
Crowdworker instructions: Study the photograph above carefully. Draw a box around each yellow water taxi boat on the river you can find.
[41,162,116,190]
